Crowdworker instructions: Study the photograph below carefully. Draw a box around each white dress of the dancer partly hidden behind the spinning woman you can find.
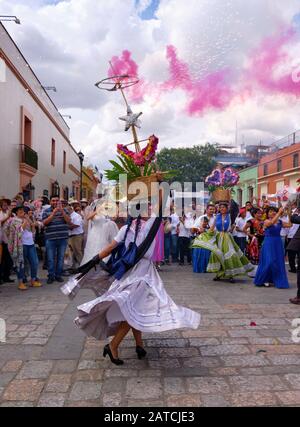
[81,214,119,265]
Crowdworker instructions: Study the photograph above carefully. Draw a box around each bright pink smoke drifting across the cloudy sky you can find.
[109,28,300,116]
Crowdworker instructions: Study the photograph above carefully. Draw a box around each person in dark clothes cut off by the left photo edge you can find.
[0,197,14,283]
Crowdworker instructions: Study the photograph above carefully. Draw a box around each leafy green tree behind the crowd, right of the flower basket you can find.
[157,143,219,183]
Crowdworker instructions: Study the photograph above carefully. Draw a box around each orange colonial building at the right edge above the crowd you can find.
[258,139,300,197]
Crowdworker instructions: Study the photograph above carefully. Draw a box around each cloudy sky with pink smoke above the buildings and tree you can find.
[0,0,300,170]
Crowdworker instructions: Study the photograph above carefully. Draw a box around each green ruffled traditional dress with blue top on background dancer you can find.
[202,214,253,279]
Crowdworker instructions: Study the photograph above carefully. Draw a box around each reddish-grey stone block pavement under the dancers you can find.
[0,266,300,407]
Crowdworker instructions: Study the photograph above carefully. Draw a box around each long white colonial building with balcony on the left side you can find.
[0,23,80,199]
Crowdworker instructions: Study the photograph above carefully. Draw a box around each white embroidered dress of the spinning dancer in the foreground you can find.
[75,219,200,340]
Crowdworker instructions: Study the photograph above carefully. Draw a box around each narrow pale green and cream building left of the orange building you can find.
[234,165,258,206]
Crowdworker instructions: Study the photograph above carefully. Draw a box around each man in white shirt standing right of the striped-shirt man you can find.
[69,205,84,268]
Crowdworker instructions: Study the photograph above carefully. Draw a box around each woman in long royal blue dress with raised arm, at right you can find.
[254,207,291,289]
